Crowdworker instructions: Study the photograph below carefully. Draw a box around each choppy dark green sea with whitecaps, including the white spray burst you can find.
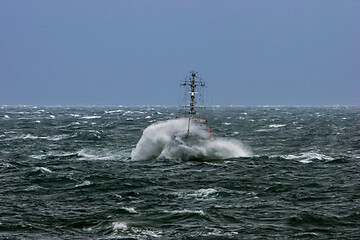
[0,106,360,239]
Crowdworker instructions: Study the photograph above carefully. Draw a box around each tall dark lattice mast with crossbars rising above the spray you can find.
[180,71,206,136]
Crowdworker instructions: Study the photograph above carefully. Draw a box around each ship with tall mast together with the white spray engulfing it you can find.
[131,71,251,161]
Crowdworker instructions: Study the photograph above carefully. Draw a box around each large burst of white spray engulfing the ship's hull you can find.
[131,118,252,160]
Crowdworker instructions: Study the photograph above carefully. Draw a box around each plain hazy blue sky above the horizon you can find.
[0,0,360,106]
